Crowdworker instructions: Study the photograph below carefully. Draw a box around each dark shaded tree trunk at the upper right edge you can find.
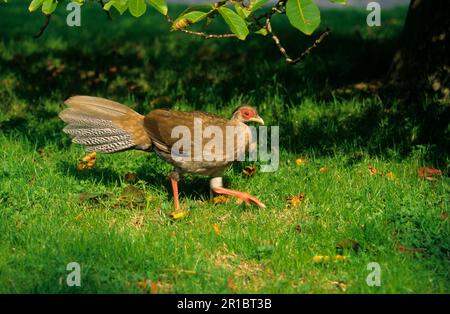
[388,0,450,102]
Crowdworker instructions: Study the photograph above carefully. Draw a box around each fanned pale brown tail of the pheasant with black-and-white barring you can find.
[59,96,151,153]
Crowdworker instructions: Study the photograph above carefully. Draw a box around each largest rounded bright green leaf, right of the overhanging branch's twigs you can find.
[286,0,320,35]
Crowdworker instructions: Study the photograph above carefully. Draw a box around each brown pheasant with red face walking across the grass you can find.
[59,96,265,211]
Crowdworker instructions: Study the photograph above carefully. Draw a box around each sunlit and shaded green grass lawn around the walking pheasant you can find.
[0,2,450,293]
